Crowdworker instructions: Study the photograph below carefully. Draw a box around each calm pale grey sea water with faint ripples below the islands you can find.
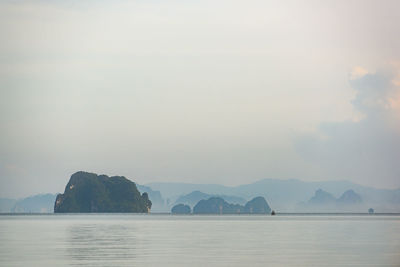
[0,214,400,266]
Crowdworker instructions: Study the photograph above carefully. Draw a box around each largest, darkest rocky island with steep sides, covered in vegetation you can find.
[54,172,151,213]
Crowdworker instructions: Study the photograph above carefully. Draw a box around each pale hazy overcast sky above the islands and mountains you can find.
[0,0,400,197]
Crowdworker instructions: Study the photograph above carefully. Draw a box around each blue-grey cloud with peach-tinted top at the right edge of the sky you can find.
[296,64,400,187]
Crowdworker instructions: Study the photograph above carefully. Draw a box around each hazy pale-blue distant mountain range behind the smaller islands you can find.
[146,179,400,212]
